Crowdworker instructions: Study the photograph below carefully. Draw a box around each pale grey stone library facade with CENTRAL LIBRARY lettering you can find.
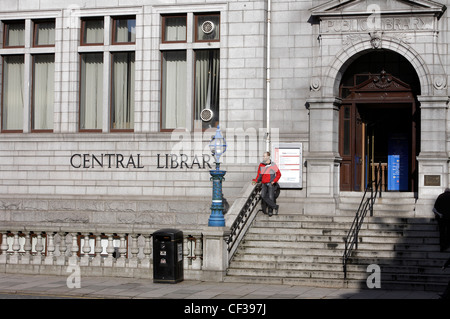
[0,0,450,229]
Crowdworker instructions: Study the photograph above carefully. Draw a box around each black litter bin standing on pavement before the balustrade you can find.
[153,229,184,283]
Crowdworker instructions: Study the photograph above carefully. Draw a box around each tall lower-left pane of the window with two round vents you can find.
[161,51,187,130]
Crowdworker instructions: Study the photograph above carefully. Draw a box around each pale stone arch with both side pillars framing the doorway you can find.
[305,40,449,202]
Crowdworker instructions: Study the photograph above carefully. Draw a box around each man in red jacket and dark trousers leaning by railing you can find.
[253,152,281,216]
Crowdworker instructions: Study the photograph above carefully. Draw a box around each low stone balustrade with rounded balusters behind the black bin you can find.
[0,227,203,279]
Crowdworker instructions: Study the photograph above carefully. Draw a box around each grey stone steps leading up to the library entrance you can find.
[225,193,450,292]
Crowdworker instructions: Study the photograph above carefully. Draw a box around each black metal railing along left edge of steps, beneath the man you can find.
[226,183,261,260]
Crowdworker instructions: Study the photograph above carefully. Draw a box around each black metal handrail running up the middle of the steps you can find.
[342,162,381,279]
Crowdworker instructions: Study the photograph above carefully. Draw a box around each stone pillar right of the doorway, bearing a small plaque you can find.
[417,96,449,204]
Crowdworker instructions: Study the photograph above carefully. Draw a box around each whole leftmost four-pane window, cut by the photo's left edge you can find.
[1,18,55,133]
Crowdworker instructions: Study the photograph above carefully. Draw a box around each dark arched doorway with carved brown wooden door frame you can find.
[339,50,420,192]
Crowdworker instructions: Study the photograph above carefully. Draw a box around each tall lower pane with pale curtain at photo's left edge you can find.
[2,55,24,132]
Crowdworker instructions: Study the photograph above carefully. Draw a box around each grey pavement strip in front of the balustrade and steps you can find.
[0,273,439,301]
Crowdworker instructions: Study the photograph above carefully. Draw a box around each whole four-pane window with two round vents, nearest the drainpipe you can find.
[160,12,220,131]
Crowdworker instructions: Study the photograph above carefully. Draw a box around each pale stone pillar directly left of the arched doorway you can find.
[305,97,341,214]
